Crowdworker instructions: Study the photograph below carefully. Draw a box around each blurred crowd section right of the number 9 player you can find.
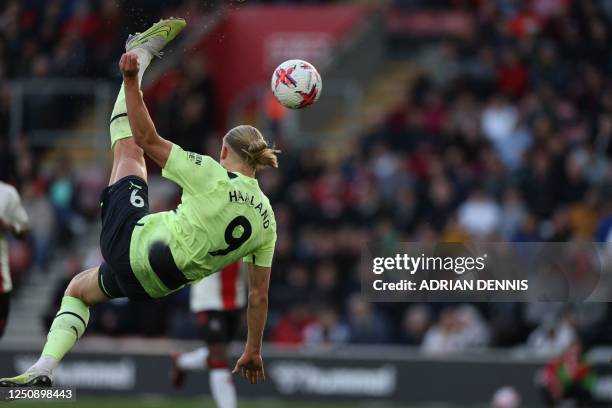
[262,0,612,355]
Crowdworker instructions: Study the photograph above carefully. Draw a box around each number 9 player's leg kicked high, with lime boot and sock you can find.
[109,18,186,185]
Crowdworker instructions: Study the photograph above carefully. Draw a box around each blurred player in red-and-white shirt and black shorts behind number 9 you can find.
[170,263,246,408]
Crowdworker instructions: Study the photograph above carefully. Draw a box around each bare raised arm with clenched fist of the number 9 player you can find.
[119,52,172,167]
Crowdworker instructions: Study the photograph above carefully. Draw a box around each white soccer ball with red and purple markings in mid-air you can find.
[272,60,323,109]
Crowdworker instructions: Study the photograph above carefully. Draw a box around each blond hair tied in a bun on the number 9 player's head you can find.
[223,125,280,170]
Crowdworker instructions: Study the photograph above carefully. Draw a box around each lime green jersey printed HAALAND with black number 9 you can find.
[130,145,276,298]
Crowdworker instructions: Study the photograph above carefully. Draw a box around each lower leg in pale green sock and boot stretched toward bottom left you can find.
[0,268,109,387]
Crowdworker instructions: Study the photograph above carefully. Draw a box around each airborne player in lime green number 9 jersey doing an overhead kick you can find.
[0,18,277,386]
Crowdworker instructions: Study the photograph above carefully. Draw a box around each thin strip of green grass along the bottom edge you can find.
[11,397,475,408]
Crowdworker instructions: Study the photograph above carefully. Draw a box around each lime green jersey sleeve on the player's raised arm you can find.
[162,144,226,194]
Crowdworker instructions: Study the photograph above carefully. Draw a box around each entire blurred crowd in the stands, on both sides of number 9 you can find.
[0,0,612,355]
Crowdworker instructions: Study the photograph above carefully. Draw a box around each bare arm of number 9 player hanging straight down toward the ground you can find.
[232,264,271,384]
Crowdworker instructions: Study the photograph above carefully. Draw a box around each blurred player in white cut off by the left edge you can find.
[0,181,29,338]
